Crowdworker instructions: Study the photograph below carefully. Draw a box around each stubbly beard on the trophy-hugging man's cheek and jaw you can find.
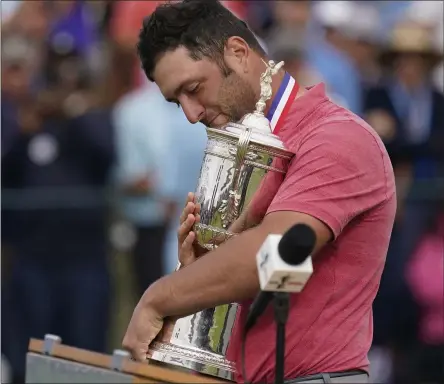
[218,68,257,122]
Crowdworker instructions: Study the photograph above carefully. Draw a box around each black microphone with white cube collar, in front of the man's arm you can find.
[244,224,316,334]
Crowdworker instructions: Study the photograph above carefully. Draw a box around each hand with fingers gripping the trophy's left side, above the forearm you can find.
[177,192,207,267]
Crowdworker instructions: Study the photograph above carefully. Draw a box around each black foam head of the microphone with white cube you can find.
[278,224,316,265]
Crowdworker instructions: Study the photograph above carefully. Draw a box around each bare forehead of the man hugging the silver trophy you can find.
[153,47,220,99]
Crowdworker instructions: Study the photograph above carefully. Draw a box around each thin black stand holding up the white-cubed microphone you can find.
[273,292,290,384]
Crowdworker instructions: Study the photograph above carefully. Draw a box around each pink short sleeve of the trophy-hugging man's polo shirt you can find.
[267,121,388,238]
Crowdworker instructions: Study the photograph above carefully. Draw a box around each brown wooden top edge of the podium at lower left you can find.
[28,339,229,384]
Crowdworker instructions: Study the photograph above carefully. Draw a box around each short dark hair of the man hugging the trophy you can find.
[137,0,265,81]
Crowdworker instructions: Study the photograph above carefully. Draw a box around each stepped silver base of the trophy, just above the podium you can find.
[150,342,235,381]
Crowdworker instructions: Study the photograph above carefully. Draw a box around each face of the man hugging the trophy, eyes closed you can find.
[153,43,259,128]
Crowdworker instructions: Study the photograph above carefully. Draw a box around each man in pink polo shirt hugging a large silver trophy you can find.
[123,0,396,383]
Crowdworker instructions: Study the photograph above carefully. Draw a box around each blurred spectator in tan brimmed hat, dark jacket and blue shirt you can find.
[365,23,444,187]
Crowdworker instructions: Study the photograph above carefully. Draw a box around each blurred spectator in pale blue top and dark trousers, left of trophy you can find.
[113,85,175,297]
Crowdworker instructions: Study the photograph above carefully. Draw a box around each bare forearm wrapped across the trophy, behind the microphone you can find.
[143,226,268,317]
